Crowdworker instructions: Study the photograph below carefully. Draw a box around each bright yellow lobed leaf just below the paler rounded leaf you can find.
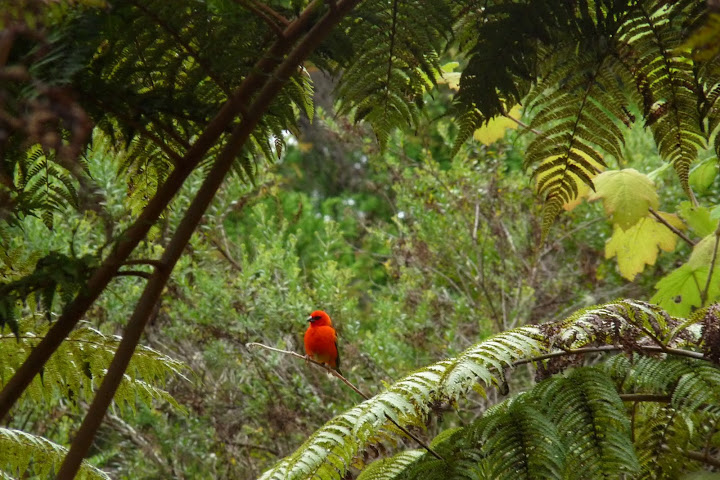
[605,212,683,280]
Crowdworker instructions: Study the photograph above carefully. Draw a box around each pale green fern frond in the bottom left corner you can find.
[0,427,110,480]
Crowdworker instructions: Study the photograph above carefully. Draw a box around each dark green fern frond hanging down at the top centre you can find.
[337,0,453,147]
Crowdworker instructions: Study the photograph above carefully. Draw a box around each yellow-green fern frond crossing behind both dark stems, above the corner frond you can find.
[0,317,186,409]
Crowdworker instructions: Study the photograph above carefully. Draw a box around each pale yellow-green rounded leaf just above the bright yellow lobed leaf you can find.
[588,168,659,230]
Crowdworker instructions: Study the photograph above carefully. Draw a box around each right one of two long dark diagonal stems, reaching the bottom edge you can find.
[56,0,361,480]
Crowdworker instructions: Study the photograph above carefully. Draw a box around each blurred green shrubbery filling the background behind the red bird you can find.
[0,63,720,479]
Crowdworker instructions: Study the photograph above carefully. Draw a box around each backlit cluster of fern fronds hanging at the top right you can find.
[456,0,720,232]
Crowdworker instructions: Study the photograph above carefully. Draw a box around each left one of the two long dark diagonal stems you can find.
[0,0,330,420]
